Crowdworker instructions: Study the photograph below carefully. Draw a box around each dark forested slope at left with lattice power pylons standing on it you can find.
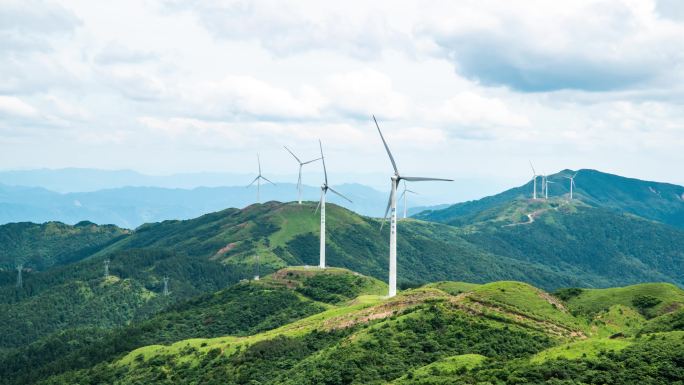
[0,249,251,350]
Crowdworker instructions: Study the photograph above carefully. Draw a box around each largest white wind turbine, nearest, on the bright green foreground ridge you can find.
[373,115,453,297]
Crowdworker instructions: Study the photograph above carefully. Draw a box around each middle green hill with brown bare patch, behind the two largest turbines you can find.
[89,202,592,287]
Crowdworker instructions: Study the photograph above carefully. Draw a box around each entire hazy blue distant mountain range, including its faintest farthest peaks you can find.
[0,168,503,228]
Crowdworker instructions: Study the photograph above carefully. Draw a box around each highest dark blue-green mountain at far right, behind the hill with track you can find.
[415,169,684,228]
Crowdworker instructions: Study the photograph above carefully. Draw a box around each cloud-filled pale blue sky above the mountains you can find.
[0,0,684,190]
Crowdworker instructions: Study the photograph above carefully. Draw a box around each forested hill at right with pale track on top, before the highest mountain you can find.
[452,200,684,287]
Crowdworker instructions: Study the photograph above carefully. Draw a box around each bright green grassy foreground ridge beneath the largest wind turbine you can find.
[21,267,684,385]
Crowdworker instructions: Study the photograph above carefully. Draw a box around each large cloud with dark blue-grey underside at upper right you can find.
[419,1,684,92]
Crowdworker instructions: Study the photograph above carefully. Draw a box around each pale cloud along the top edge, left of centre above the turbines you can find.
[166,0,407,58]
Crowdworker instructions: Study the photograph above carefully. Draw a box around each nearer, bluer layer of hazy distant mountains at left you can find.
[0,184,396,228]
